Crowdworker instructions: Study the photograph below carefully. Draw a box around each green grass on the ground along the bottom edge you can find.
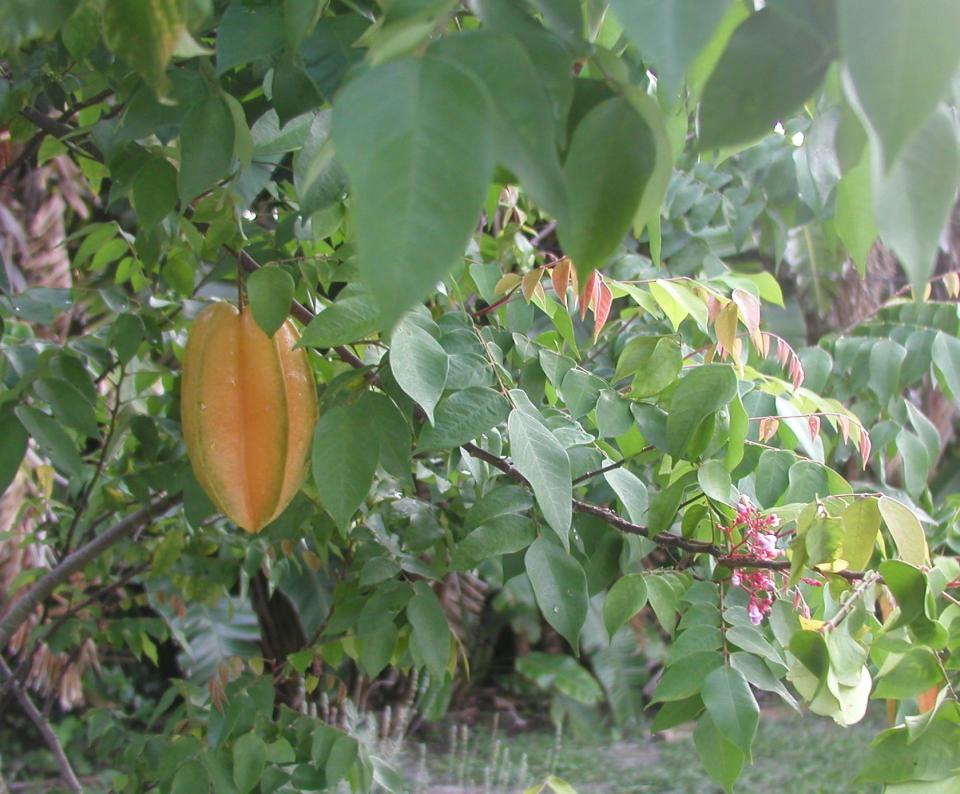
[408,710,883,794]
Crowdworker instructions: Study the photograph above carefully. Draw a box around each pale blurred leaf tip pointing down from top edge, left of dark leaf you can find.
[610,0,730,101]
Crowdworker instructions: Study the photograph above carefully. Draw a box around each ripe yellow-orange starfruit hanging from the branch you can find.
[180,302,317,532]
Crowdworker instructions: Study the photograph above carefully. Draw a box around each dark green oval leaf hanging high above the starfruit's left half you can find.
[177,95,234,206]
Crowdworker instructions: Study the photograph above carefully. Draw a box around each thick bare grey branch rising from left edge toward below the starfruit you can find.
[0,494,181,648]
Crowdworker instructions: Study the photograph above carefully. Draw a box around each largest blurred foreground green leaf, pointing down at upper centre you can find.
[334,55,493,327]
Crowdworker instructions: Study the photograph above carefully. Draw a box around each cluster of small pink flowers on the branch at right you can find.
[720,496,781,626]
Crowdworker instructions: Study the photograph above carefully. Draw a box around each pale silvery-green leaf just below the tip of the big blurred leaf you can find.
[390,319,450,424]
